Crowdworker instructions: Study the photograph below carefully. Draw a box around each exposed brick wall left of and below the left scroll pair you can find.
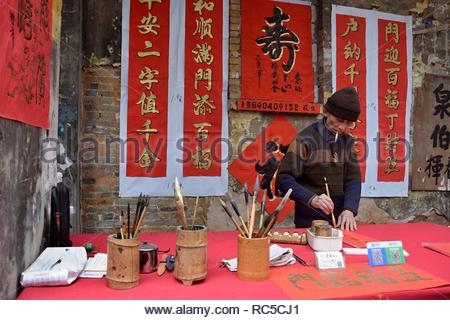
[78,66,220,232]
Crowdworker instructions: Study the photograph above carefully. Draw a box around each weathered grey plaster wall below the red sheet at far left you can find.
[0,119,48,299]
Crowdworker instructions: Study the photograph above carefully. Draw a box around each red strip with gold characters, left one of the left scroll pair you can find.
[126,1,170,177]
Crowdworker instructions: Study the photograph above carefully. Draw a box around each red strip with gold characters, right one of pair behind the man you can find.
[378,19,408,181]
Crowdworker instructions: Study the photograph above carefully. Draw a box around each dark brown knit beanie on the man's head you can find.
[325,87,361,121]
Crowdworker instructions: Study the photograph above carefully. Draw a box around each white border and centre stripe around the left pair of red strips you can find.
[119,0,231,197]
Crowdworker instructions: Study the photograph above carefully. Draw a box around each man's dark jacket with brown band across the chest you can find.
[276,118,361,228]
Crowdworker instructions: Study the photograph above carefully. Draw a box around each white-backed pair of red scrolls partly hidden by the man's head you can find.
[332,5,412,197]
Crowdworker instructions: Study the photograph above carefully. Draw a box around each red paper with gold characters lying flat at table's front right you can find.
[270,263,450,300]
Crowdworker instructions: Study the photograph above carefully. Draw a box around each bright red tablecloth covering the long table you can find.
[18,223,450,300]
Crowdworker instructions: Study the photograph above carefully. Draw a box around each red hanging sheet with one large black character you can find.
[241,0,314,107]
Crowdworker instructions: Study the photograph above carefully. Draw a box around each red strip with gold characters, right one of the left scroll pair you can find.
[183,0,223,177]
